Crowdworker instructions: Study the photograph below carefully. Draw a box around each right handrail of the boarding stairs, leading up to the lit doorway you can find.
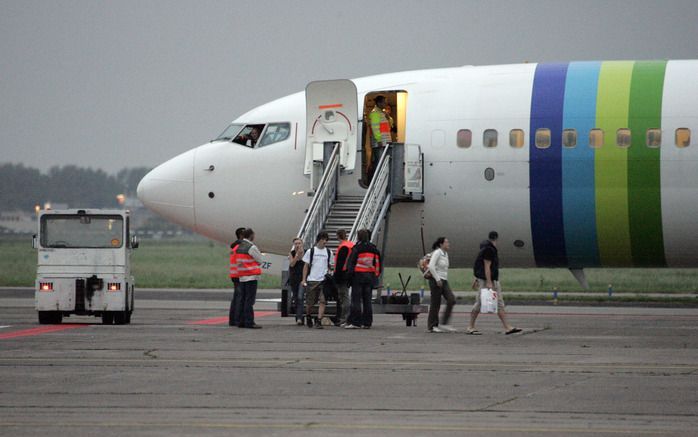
[349,146,391,242]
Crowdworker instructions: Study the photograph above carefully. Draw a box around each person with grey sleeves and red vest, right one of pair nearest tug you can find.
[235,228,262,329]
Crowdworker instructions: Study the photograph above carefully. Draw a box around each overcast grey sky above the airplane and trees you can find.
[0,0,698,173]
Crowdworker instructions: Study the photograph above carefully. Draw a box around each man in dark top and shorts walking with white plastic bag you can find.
[466,231,521,335]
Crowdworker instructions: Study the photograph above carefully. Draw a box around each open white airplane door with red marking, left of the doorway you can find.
[305,79,359,174]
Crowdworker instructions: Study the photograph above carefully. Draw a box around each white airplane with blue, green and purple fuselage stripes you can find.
[137,60,698,284]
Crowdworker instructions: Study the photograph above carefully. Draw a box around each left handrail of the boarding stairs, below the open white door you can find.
[297,143,340,249]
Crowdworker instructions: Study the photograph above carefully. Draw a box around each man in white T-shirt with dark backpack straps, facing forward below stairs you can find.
[303,232,332,329]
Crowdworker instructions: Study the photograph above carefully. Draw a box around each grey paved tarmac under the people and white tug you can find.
[0,288,698,436]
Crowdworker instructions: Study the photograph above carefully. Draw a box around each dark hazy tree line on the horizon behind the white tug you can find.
[0,164,150,211]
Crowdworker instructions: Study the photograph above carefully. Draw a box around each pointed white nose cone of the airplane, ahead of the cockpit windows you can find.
[136,150,196,228]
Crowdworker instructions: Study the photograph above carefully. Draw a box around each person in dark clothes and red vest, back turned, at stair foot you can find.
[345,229,383,329]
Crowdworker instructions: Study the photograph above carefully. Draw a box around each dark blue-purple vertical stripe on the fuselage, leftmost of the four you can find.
[529,64,568,267]
